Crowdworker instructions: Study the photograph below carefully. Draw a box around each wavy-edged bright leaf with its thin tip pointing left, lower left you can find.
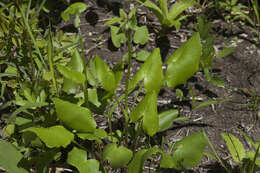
[23,125,74,148]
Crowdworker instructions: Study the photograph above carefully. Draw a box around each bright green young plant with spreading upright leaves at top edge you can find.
[137,0,200,30]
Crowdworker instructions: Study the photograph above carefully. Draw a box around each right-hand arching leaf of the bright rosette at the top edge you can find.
[169,0,199,21]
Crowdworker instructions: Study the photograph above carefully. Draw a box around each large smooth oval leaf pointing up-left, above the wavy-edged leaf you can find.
[52,98,96,132]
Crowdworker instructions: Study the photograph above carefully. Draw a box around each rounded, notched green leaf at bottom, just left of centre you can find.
[102,143,133,168]
